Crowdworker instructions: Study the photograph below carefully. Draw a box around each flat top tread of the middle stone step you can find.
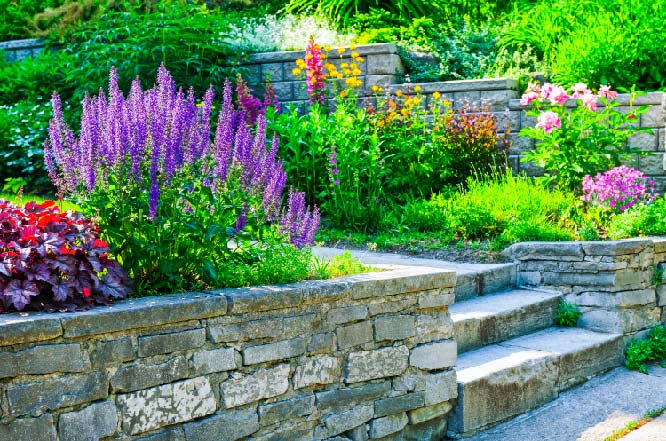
[449,288,562,316]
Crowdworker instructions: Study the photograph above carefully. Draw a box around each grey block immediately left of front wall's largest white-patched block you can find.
[58,401,118,441]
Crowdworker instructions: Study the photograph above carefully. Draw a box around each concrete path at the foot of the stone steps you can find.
[465,367,666,441]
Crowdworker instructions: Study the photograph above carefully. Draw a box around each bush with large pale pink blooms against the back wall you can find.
[520,83,647,191]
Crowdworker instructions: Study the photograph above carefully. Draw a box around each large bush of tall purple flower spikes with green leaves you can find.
[44,66,319,292]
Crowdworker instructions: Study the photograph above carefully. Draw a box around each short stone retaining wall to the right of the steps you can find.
[504,238,666,337]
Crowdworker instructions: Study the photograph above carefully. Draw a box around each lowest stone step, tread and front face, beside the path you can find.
[448,328,624,438]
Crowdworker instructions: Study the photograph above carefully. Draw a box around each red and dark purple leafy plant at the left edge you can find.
[0,199,132,312]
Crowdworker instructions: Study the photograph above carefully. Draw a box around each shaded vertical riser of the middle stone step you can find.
[453,297,560,353]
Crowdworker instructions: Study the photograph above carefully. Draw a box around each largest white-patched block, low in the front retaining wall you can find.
[116,377,217,435]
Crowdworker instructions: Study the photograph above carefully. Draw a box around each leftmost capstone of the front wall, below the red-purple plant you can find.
[0,312,62,346]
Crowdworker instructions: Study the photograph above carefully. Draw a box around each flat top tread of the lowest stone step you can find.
[456,327,622,383]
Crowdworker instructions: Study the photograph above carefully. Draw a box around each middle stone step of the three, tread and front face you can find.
[449,289,562,353]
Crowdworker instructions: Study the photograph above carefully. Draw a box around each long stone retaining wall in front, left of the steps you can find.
[0,267,457,441]
